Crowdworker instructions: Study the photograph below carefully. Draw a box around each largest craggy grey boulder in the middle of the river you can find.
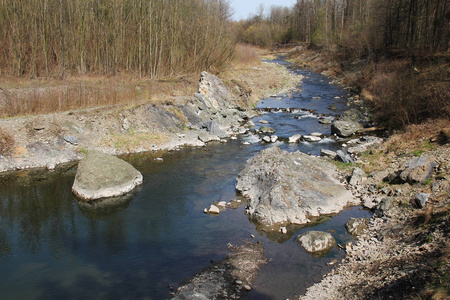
[236,147,357,225]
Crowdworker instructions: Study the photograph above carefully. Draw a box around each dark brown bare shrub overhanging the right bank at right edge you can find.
[368,61,450,129]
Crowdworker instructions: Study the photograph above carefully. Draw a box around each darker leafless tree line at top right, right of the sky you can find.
[240,0,450,52]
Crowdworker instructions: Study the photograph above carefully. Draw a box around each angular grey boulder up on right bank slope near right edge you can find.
[400,156,437,183]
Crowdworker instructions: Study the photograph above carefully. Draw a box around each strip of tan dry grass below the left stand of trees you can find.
[0,73,198,118]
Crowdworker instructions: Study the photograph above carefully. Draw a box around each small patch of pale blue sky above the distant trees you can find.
[230,0,297,21]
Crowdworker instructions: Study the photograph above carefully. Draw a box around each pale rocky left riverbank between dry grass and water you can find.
[0,54,301,172]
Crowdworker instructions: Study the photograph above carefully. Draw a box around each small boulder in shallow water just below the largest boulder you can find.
[297,231,336,254]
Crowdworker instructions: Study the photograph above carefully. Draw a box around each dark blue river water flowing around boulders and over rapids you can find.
[0,61,369,300]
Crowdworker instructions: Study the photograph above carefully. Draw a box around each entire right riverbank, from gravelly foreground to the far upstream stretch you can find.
[284,46,450,299]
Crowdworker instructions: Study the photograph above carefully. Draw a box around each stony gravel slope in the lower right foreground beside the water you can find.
[300,130,450,299]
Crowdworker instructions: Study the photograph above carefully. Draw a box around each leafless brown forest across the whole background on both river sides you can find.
[0,0,450,128]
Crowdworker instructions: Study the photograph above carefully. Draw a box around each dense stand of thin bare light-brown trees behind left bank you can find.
[0,0,235,78]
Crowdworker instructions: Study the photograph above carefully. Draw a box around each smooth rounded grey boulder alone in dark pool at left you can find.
[72,151,143,201]
